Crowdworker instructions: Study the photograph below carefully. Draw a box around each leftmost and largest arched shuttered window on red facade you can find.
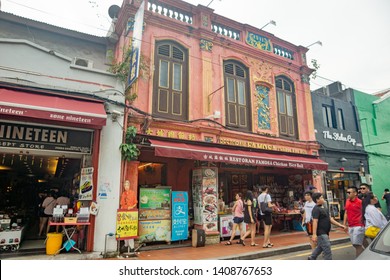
[153,41,188,120]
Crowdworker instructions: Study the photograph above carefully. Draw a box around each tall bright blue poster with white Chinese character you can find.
[172,191,188,241]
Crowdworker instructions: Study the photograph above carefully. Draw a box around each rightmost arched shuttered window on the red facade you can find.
[276,76,298,138]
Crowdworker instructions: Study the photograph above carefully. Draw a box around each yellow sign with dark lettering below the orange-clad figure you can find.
[116,209,138,240]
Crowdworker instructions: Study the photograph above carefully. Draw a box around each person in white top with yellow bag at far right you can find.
[364,192,387,239]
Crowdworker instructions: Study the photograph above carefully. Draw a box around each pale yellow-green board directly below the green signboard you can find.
[139,220,171,243]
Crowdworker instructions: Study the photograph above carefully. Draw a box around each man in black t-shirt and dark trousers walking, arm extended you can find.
[307,193,345,260]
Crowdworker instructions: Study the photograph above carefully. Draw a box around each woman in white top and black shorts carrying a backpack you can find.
[258,186,275,248]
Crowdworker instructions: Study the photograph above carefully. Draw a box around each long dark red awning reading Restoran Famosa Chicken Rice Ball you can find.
[150,139,328,170]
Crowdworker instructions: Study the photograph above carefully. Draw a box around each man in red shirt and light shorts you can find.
[344,187,364,257]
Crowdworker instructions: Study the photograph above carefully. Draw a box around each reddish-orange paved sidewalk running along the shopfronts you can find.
[0,229,352,260]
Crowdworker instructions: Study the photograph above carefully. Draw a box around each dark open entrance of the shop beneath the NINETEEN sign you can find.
[0,152,83,254]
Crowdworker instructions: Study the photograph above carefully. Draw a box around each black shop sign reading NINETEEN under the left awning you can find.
[0,122,93,154]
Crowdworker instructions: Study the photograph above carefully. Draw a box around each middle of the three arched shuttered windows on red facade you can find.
[223,60,251,131]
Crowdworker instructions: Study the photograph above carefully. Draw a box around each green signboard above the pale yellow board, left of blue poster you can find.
[140,187,171,209]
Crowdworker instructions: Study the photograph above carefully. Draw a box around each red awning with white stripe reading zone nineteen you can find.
[0,89,107,127]
